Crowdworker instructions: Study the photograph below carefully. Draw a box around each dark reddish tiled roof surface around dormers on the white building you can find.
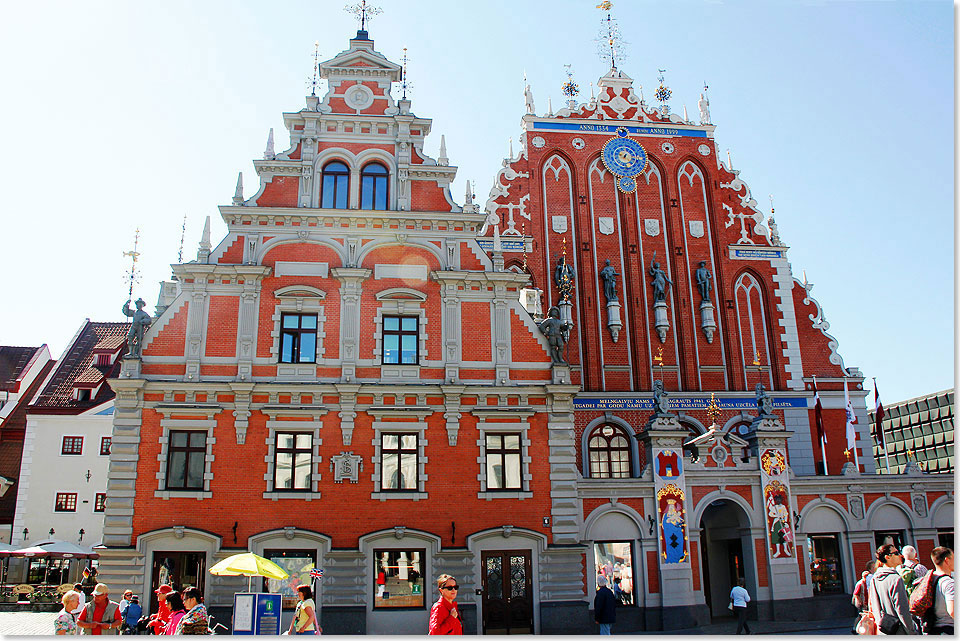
[30,321,130,413]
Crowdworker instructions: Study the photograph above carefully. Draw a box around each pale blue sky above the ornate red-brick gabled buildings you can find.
[0,0,955,403]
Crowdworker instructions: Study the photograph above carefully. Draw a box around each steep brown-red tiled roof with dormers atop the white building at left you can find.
[30,321,130,414]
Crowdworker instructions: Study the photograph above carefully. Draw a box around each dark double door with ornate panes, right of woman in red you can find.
[480,550,533,634]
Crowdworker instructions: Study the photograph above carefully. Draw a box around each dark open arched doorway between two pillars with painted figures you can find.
[700,499,757,617]
